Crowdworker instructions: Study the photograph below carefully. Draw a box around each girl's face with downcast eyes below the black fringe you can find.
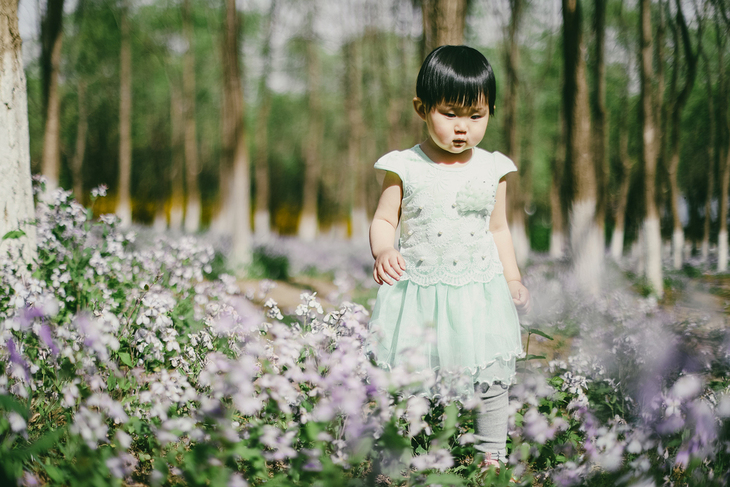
[413,98,489,160]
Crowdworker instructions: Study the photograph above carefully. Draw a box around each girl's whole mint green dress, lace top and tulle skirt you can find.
[369,146,523,396]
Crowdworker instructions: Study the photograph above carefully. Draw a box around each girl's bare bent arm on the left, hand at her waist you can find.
[370,171,406,286]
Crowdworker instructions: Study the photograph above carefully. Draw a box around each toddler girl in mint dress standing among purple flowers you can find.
[370,46,530,464]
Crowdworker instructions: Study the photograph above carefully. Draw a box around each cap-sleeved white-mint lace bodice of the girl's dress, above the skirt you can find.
[375,146,517,286]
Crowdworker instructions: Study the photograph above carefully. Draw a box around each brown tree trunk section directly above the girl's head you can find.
[421,0,467,54]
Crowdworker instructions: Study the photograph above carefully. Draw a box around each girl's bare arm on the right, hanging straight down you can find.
[489,178,530,312]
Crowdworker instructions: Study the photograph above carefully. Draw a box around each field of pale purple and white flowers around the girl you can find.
[0,191,730,487]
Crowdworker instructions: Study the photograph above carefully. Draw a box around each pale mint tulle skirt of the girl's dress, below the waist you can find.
[369,275,523,395]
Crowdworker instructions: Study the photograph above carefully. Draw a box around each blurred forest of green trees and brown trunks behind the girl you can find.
[8,0,730,294]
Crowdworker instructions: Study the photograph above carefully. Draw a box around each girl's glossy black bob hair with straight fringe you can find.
[416,46,497,115]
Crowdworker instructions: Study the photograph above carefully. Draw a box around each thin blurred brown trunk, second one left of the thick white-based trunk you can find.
[168,76,185,231]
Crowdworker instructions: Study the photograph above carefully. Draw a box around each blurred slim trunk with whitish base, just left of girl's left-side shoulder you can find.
[345,39,370,241]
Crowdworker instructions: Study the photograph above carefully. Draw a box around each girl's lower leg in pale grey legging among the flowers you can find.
[474,382,509,462]
